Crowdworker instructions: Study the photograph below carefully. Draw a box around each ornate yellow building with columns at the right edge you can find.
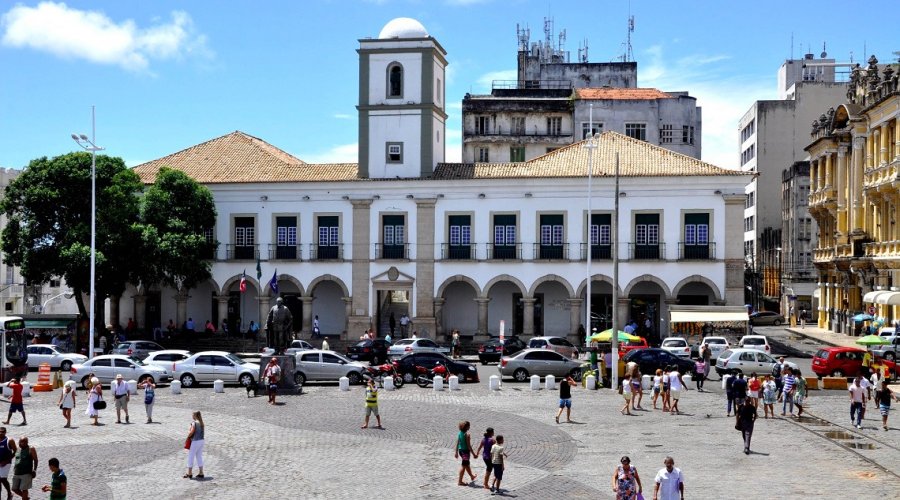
[806,56,900,333]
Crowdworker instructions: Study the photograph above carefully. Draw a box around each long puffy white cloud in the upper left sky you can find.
[0,2,212,72]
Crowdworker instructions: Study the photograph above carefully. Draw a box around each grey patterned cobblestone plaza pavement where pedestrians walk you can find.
[8,382,900,499]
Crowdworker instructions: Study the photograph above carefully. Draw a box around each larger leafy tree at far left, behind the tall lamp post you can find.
[0,152,144,315]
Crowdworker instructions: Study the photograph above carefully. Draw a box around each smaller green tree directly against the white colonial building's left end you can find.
[141,167,218,289]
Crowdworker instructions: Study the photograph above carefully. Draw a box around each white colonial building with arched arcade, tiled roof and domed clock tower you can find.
[121,19,751,344]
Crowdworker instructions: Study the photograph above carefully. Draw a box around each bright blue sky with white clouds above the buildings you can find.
[0,0,900,168]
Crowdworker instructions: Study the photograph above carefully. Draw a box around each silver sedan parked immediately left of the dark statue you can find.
[172,351,259,388]
